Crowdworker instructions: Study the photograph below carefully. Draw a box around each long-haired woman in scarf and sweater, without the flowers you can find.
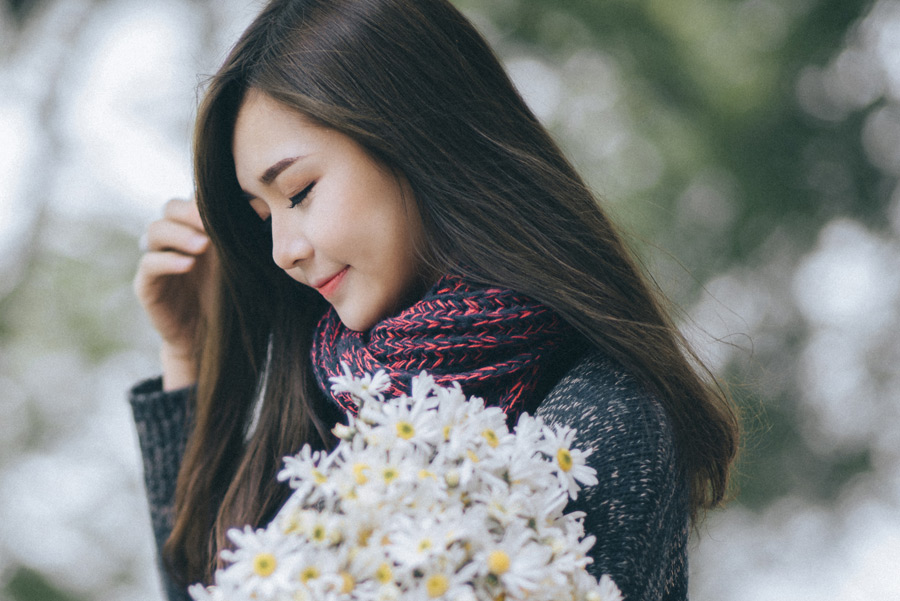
[131,0,737,599]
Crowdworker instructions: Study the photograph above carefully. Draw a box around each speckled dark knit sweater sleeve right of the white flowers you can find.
[536,356,689,601]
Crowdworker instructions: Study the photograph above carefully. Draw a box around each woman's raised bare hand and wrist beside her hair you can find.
[134,199,216,390]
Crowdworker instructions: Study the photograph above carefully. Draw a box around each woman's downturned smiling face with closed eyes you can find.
[232,90,422,331]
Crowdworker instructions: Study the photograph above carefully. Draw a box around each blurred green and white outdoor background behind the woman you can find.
[0,0,900,601]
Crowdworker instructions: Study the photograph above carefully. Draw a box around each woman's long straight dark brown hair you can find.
[165,0,738,581]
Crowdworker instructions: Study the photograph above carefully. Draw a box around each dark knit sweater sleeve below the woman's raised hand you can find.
[128,378,193,601]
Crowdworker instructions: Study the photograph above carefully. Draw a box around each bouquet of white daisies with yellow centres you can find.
[190,366,622,601]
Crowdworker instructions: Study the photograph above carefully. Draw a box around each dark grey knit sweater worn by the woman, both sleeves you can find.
[129,354,688,601]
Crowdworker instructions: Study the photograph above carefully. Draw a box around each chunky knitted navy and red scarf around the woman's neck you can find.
[312,275,577,422]
